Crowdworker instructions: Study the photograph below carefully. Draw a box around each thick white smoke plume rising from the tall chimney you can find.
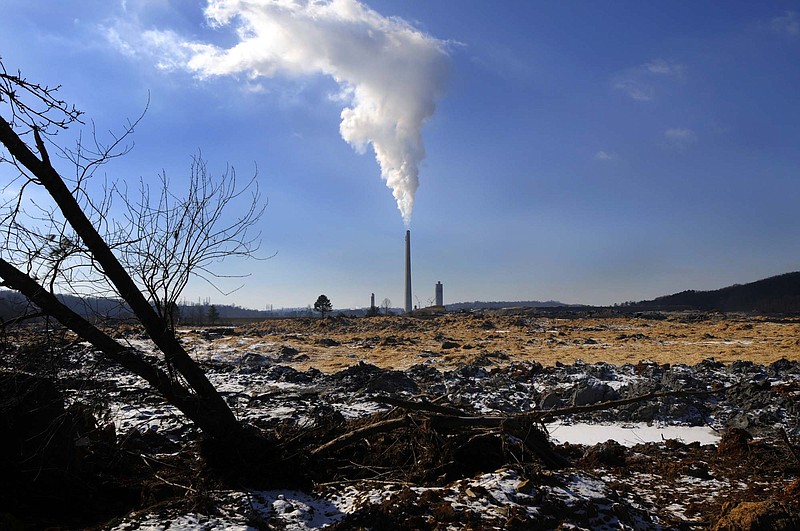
[179,0,449,226]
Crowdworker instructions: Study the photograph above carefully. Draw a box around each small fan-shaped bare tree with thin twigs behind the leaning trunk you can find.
[121,155,266,328]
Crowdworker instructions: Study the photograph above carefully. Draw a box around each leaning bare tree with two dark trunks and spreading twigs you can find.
[0,60,263,440]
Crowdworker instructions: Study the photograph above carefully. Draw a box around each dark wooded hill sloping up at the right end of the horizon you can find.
[626,272,800,313]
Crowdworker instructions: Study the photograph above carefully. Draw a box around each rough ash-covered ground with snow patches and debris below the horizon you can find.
[0,309,800,530]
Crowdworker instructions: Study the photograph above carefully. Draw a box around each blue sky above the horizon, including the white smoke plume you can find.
[0,0,800,309]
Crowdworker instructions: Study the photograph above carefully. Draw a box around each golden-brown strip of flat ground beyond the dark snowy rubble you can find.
[206,313,800,372]
